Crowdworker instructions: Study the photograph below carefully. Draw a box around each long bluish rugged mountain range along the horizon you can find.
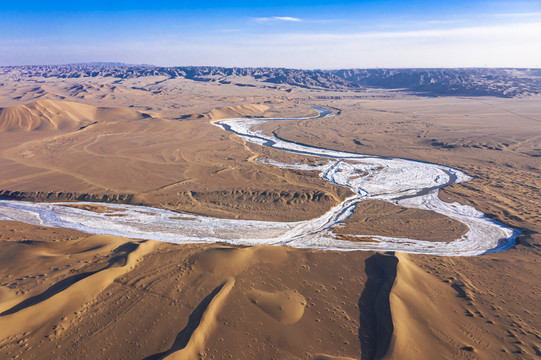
[0,63,541,97]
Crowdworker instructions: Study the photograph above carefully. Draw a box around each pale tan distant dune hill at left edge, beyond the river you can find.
[0,100,149,132]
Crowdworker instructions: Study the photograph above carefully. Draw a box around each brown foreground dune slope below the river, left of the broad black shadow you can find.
[0,221,375,359]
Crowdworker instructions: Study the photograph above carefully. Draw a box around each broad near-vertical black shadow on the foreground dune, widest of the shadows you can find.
[359,253,398,360]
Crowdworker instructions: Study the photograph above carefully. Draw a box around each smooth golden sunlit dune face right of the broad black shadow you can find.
[384,253,479,359]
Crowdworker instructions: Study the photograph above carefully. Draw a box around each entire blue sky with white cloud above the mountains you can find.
[0,0,541,69]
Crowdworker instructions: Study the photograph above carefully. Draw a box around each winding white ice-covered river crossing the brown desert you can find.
[0,107,519,256]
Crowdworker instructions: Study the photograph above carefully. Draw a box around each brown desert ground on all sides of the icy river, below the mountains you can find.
[0,75,541,359]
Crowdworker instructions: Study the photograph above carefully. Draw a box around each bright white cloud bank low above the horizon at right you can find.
[247,22,541,68]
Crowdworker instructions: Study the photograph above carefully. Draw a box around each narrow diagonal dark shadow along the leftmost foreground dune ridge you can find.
[0,242,139,316]
